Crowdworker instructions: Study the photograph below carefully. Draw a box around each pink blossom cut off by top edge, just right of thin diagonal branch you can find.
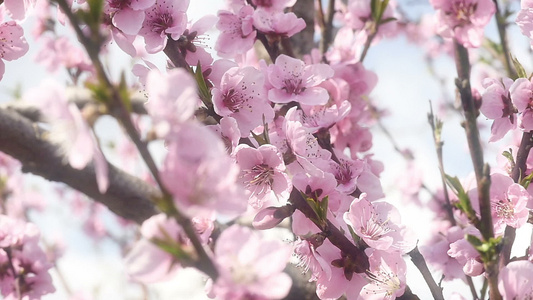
[104,0,155,35]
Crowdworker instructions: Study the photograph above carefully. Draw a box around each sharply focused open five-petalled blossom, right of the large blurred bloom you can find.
[235,145,292,209]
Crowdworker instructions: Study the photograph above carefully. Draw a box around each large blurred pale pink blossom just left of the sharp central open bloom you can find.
[161,122,247,217]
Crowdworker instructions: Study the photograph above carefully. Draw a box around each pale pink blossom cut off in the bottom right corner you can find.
[498,260,533,299]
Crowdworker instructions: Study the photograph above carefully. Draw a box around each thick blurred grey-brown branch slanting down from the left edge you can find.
[0,108,161,224]
